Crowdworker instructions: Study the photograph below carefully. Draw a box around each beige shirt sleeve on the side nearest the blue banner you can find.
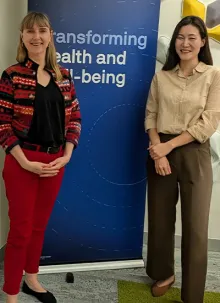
[144,75,158,132]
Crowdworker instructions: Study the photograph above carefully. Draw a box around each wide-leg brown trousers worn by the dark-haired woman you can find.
[146,134,212,303]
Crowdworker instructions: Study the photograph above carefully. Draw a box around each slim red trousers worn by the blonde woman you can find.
[3,149,64,295]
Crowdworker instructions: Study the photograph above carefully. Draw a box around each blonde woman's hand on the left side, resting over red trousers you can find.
[22,161,59,177]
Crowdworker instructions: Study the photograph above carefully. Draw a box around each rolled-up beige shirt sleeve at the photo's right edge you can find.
[187,70,220,143]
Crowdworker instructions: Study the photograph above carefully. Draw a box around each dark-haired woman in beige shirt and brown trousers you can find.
[145,16,220,303]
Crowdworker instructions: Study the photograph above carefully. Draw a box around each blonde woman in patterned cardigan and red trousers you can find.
[0,12,81,303]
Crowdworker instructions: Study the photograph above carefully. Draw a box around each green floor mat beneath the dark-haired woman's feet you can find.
[118,281,220,303]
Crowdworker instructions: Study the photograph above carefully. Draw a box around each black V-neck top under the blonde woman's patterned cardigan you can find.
[28,78,65,147]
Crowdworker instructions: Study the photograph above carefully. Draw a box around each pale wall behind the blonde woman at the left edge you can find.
[0,0,27,249]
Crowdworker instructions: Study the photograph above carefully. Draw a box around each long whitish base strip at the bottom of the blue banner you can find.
[39,259,144,275]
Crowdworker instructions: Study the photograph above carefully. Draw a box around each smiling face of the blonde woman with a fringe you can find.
[21,23,52,56]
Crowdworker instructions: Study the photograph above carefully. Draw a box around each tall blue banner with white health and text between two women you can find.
[29,0,160,264]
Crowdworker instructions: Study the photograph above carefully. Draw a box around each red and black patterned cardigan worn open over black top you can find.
[0,59,81,153]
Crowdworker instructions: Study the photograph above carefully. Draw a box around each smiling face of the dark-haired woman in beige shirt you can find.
[175,25,205,61]
